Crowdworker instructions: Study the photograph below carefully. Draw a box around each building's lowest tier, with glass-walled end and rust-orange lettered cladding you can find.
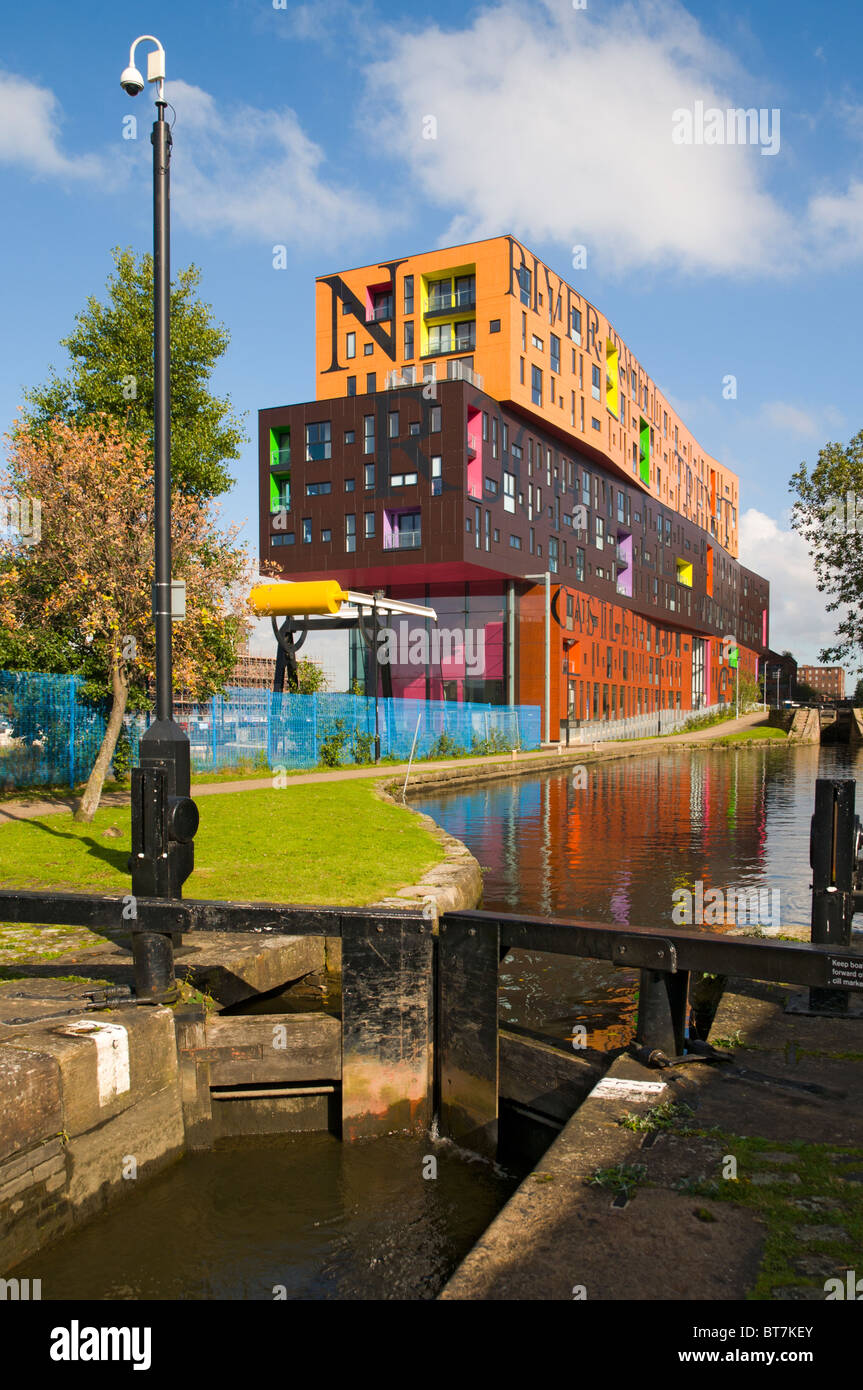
[340,580,759,738]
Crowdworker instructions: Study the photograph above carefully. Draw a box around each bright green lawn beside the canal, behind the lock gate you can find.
[0,781,443,911]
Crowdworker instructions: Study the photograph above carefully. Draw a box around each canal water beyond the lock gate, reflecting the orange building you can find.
[414,744,863,1049]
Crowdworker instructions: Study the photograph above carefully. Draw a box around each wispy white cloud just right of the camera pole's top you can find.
[167,82,384,249]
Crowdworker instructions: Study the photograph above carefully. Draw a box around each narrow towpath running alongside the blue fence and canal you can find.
[0,710,764,826]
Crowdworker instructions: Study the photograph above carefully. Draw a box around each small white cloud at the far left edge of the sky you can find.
[0,72,103,179]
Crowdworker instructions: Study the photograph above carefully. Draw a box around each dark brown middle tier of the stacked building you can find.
[260,381,769,655]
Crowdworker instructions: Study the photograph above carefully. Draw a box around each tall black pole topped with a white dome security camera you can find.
[120,35,199,1004]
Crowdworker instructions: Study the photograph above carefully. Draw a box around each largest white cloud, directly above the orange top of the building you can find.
[367,0,799,272]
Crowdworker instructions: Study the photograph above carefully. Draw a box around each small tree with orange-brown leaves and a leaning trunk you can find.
[0,417,252,820]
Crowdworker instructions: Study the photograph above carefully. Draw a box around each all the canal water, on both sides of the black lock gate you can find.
[15,745,862,1300]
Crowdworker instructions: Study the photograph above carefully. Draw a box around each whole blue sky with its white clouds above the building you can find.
[0,0,863,683]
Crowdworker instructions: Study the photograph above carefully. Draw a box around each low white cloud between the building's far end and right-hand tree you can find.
[739,507,839,666]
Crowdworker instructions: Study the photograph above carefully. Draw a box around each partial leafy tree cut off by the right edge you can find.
[789,430,863,666]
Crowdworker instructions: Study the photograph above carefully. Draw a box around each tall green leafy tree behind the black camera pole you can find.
[22,246,241,498]
